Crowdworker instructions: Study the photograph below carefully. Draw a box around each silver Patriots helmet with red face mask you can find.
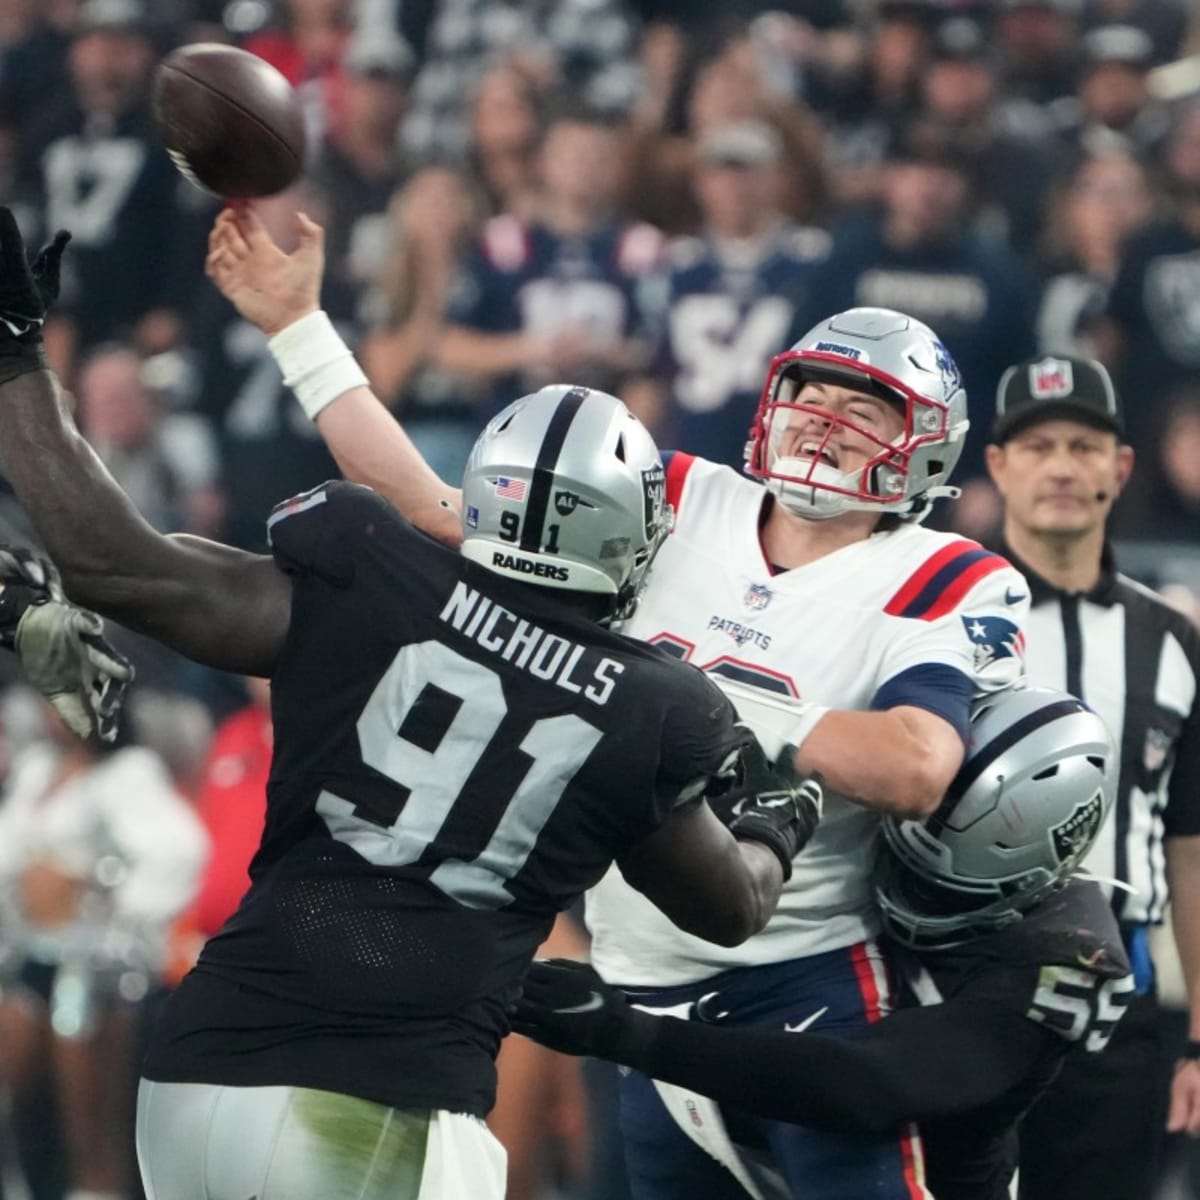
[745,308,968,521]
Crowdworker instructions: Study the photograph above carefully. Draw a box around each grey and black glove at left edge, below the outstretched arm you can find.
[0,546,133,742]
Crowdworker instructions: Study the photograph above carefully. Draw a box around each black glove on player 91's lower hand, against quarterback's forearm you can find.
[708,739,824,882]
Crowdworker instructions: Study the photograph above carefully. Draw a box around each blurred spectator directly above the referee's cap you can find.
[1037,154,1154,358]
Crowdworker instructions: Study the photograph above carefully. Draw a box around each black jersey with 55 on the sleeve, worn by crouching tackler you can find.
[920,881,1134,1200]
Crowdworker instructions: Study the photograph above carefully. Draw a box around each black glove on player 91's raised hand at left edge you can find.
[0,205,71,382]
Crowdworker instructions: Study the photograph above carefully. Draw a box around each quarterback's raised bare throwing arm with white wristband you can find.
[205,205,462,546]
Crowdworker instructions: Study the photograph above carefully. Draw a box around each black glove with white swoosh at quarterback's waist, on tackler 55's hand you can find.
[509,959,653,1062]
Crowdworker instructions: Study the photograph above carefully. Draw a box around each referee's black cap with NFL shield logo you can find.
[991,355,1124,443]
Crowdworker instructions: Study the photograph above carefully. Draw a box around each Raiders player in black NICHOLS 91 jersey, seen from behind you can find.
[0,209,820,1200]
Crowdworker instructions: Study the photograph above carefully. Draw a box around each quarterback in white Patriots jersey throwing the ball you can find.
[209,210,1028,1200]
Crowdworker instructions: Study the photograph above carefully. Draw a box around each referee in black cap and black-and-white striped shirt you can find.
[988,358,1200,1200]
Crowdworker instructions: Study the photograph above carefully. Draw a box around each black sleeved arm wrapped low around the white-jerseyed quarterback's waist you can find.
[620,998,1062,1134]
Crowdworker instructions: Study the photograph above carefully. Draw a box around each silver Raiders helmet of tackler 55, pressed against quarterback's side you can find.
[876,688,1117,947]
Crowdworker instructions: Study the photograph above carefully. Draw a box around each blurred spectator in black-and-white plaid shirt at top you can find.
[404,0,637,161]
